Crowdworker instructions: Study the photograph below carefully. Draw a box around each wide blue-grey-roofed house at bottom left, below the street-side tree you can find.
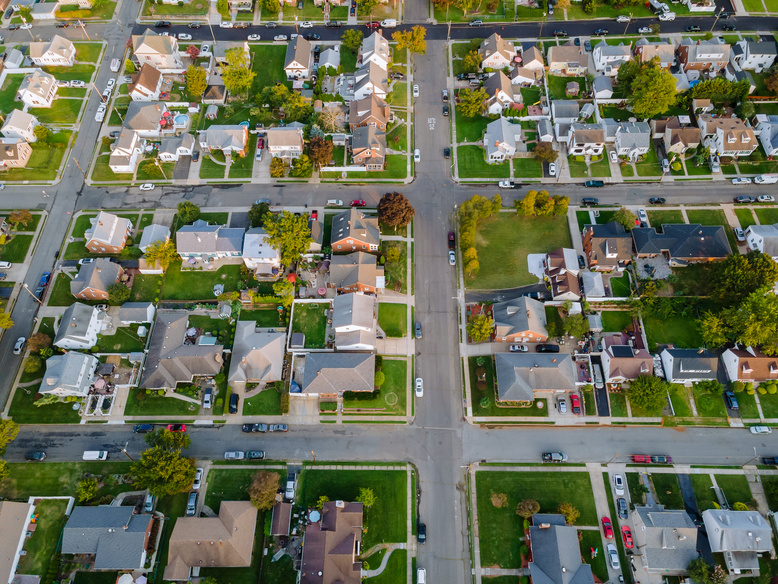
[62,505,154,571]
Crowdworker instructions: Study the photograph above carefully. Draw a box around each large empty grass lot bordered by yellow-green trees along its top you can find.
[466,213,571,290]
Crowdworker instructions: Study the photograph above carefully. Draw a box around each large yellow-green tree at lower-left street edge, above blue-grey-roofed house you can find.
[130,446,195,497]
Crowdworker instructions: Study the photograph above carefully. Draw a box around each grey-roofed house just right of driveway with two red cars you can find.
[632,505,700,576]
